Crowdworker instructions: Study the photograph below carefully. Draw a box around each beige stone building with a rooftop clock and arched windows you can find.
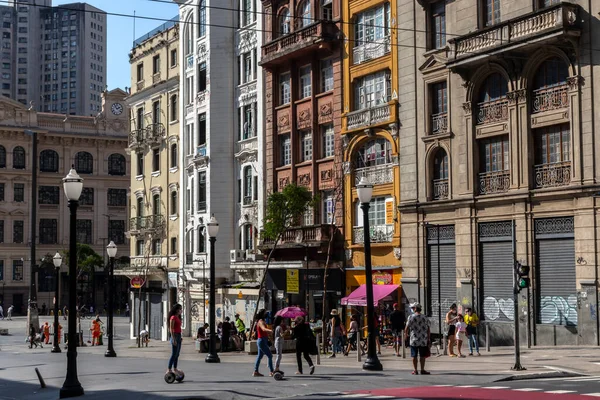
[0,89,130,313]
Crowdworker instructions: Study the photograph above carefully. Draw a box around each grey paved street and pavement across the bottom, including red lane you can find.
[0,317,600,400]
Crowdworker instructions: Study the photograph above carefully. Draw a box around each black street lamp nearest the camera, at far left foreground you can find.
[60,165,83,399]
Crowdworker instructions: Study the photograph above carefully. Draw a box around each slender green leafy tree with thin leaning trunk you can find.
[251,183,318,332]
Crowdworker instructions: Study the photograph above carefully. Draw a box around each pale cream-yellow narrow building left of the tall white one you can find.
[125,21,181,340]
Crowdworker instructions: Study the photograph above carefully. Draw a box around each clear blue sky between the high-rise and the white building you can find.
[52,0,179,90]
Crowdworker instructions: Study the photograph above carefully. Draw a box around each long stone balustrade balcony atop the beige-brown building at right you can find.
[448,3,581,68]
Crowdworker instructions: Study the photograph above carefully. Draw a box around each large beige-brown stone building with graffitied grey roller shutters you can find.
[398,0,600,345]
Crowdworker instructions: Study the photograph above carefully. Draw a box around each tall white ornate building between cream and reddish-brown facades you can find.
[174,0,264,333]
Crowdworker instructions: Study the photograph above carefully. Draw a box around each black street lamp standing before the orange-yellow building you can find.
[356,177,383,371]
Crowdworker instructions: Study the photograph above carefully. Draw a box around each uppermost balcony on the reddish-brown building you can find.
[260,21,338,68]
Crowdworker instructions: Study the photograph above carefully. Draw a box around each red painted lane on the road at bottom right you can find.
[352,386,593,400]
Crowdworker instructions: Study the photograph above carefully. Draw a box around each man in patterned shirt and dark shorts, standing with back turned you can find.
[404,303,431,375]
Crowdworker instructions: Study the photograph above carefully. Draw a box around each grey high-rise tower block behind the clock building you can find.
[0,0,106,116]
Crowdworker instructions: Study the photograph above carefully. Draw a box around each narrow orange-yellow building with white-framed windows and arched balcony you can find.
[342,0,401,310]
